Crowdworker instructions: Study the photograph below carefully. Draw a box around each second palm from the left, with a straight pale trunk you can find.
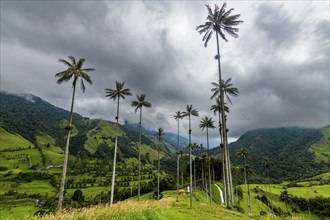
[105,81,132,205]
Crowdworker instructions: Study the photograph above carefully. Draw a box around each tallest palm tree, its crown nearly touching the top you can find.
[196,3,242,206]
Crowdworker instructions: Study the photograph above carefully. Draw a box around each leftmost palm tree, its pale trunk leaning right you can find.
[55,56,95,211]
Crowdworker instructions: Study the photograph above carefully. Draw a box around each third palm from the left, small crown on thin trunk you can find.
[132,94,151,202]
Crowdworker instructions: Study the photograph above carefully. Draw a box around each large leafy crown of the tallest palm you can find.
[196,2,243,47]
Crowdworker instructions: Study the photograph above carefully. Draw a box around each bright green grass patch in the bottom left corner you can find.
[0,199,39,220]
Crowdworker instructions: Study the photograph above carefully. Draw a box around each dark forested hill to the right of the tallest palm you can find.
[212,126,330,182]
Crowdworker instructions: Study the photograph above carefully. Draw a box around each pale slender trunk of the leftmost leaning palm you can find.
[57,79,77,211]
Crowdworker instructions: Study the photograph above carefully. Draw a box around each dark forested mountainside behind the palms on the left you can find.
[0,92,180,162]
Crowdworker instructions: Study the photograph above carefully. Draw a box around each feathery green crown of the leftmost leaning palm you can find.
[55,56,95,92]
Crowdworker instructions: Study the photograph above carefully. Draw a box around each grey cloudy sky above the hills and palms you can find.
[0,0,330,146]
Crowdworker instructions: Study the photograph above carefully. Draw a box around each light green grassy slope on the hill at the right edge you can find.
[309,126,330,163]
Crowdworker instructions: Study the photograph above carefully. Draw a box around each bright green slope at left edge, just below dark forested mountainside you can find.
[0,127,34,150]
